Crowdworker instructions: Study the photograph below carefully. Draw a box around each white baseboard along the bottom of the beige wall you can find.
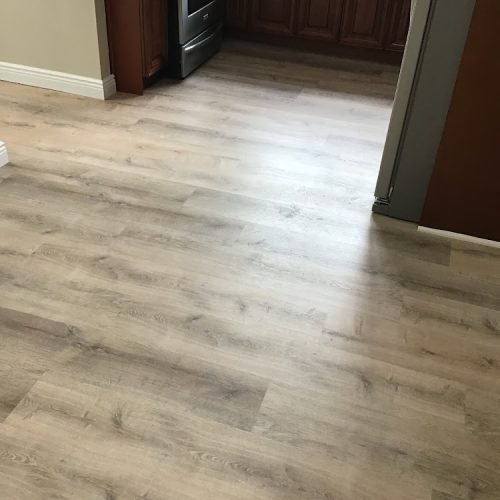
[0,62,116,99]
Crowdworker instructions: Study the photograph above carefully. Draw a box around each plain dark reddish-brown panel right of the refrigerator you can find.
[421,0,500,241]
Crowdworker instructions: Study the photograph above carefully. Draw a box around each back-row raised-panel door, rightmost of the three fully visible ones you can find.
[340,0,390,49]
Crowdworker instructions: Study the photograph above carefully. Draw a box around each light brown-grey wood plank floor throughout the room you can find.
[0,44,500,500]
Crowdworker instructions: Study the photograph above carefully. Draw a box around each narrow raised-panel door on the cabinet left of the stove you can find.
[142,0,167,78]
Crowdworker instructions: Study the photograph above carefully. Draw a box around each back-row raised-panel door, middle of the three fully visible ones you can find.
[297,0,343,41]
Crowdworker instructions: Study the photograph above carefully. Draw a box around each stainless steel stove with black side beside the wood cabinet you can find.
[168,0,224,78]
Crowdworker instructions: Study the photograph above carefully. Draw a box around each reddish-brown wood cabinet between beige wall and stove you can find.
[106,0,167,94]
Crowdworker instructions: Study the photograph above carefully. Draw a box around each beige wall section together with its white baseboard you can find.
[0,0,116,99]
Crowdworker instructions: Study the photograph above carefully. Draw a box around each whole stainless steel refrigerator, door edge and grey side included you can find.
[373,0,476,222]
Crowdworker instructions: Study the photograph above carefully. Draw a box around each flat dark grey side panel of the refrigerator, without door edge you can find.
[373,0,476,222]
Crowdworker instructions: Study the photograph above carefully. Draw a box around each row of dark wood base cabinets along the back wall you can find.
[226,0,411,62]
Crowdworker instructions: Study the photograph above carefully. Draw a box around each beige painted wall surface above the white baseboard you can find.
[0,0,110,79]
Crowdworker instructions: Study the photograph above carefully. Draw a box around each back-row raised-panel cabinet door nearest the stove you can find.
[251,0,296,35]
